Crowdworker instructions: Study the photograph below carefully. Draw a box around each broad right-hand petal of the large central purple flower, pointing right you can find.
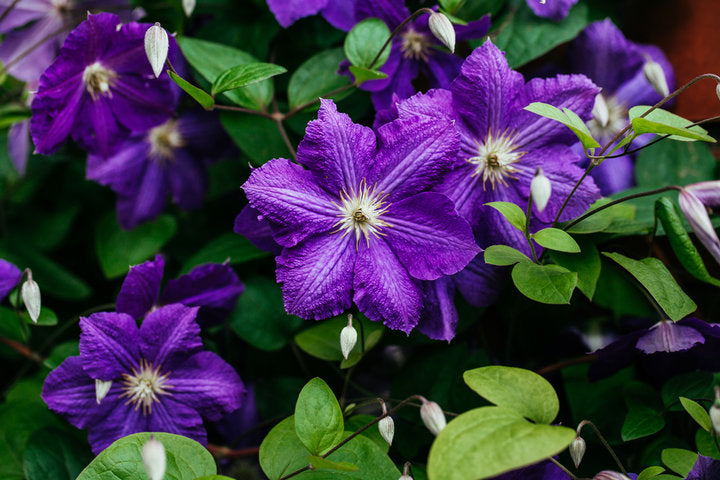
[383,192,480,280]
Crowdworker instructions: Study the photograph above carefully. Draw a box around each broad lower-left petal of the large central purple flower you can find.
[277,232,354,320]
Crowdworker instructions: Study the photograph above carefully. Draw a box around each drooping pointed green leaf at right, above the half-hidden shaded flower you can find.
[603,252,697,321]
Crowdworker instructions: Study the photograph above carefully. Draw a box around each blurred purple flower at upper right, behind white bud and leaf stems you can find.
[570,19,675,195]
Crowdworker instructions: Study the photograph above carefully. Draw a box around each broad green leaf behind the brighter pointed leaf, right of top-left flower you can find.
[177,37,273,110]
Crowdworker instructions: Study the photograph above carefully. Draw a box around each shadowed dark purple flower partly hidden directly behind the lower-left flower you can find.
[115,255,245,327]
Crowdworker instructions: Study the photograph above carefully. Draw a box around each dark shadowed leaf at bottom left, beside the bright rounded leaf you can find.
[23,429,93,480]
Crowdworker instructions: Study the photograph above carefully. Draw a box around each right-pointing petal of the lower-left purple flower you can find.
[162,352,246,420]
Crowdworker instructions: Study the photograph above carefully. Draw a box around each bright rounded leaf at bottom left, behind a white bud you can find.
[77,432,217,480]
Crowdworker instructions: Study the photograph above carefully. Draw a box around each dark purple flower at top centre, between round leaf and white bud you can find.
[343,0,490,111]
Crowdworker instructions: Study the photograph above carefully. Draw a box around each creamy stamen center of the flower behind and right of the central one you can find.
[467,131,526,190]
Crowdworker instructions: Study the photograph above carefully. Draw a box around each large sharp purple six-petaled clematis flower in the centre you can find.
[243,100,480,333]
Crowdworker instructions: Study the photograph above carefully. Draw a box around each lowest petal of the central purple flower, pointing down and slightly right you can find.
[353,238,423,334]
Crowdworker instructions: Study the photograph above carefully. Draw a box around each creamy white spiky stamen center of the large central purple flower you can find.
[330,179,392,248]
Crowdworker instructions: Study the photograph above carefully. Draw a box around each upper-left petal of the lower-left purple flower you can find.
[80,312,142,380]
